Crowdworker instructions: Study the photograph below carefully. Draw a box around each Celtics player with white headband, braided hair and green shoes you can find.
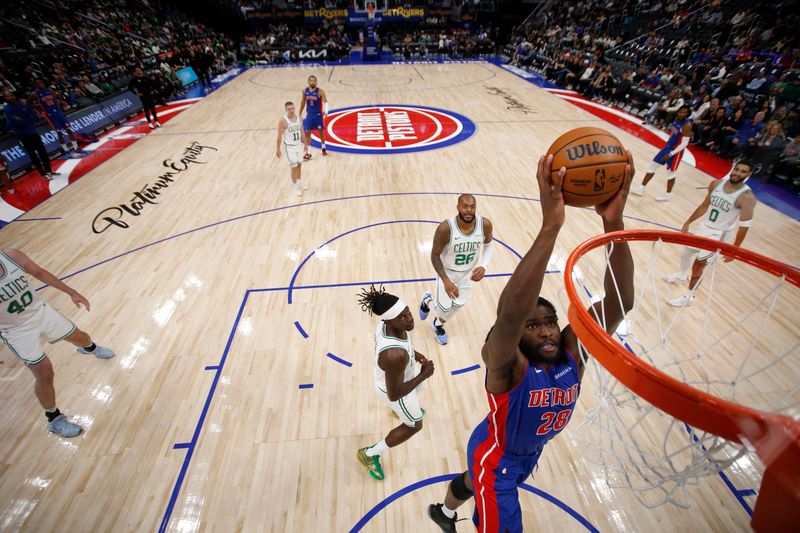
[357,285,434,480]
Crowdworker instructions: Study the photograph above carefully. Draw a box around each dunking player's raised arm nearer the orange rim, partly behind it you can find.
[561,150,635,375]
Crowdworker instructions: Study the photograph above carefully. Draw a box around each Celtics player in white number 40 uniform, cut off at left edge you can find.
[0,249,114,437]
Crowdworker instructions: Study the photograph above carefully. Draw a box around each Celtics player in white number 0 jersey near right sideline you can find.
[663,161,756,307]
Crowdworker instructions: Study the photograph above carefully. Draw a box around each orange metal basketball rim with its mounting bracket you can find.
[564,230,800,532]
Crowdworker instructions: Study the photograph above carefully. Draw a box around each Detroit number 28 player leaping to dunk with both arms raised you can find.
[428,152,634,533]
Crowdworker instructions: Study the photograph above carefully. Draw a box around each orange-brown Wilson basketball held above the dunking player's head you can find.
[547,128,628,207]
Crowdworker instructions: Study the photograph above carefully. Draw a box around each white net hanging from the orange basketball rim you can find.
[562,236,800,507]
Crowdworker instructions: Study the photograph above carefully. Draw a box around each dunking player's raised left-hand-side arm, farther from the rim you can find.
[482,155,566,394]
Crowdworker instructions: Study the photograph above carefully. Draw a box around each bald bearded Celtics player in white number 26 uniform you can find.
[419,194,494,344]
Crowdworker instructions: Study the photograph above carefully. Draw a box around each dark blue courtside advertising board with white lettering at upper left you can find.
[0,91,142,174]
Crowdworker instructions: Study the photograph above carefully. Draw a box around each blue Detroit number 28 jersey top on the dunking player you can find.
[476,352,580,456]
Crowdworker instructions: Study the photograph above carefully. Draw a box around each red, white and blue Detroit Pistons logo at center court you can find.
[311,104,475,154]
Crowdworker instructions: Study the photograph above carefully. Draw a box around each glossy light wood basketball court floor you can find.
[0,64,800,533]
